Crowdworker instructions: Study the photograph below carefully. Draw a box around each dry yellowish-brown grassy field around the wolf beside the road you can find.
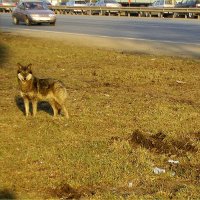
[0,33,200,200]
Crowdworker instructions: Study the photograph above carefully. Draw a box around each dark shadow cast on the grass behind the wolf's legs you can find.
[15,96,53,115]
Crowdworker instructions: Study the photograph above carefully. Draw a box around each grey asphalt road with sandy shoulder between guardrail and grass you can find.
[0,14,200,58]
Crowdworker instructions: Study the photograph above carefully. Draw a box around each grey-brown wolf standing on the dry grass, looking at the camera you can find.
[17,63,69,118]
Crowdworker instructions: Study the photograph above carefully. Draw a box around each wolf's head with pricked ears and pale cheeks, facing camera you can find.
[17,63,33,82]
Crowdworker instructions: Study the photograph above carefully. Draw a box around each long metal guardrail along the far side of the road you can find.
[0,6,200,19]
